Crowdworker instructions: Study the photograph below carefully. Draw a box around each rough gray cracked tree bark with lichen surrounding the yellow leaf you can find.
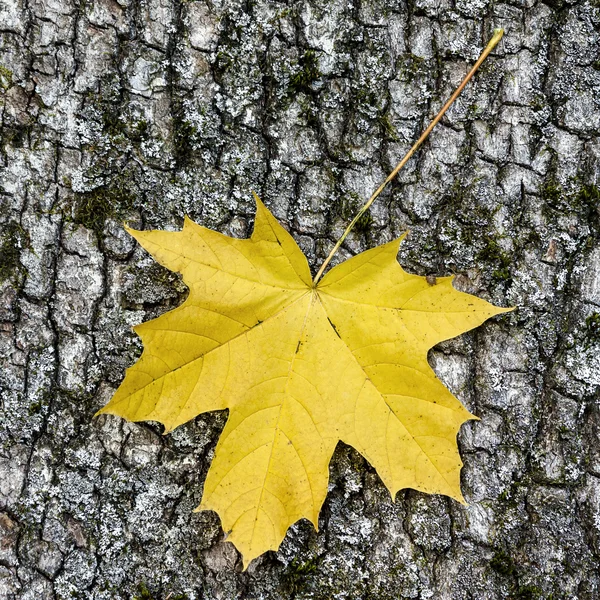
[0,0,600,600]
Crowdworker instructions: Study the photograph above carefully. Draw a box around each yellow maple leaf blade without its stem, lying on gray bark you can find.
[99,195,511,566]
